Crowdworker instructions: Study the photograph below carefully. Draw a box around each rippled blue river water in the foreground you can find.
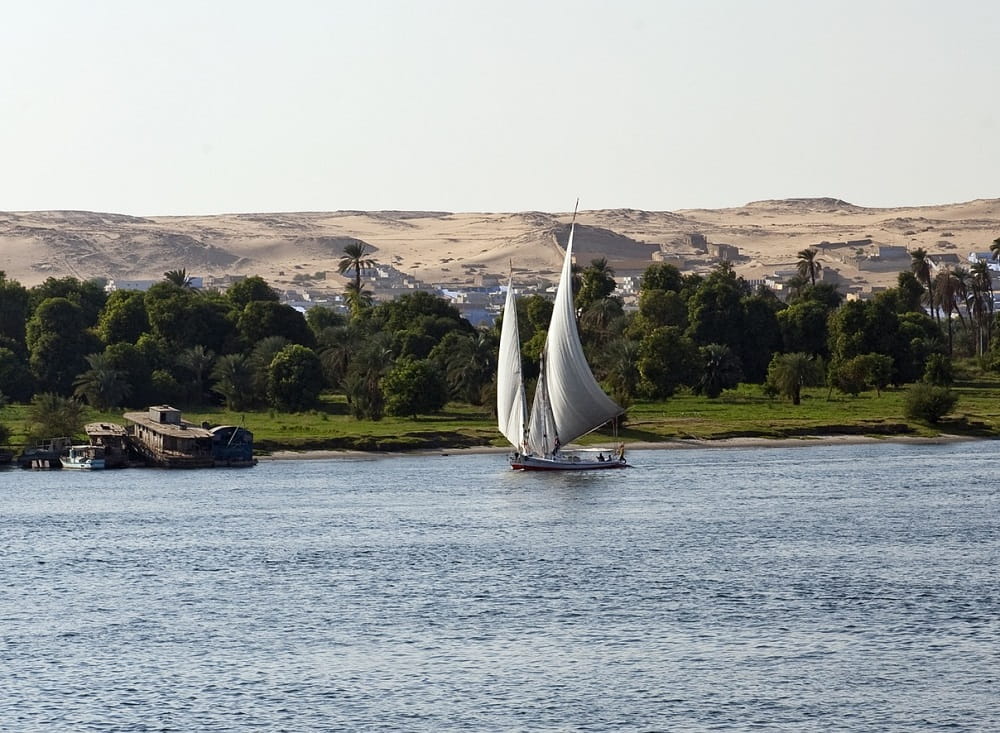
[0,442,1000,731]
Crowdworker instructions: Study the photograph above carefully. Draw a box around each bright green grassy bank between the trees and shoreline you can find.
[0,376,1000,452]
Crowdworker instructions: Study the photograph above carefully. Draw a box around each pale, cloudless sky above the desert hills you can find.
[0,0,1000,216]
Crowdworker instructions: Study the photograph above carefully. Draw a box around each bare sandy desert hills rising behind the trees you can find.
[0,198,1000,291]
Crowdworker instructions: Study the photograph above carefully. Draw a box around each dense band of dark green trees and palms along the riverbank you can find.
[0,238,1000,440]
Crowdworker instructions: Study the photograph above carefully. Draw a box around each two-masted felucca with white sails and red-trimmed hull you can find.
[497,203,628,471]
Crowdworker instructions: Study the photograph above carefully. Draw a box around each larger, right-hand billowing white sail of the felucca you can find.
[544,222,623,444]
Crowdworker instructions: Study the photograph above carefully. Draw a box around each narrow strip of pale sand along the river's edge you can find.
[258,435,986,461]
